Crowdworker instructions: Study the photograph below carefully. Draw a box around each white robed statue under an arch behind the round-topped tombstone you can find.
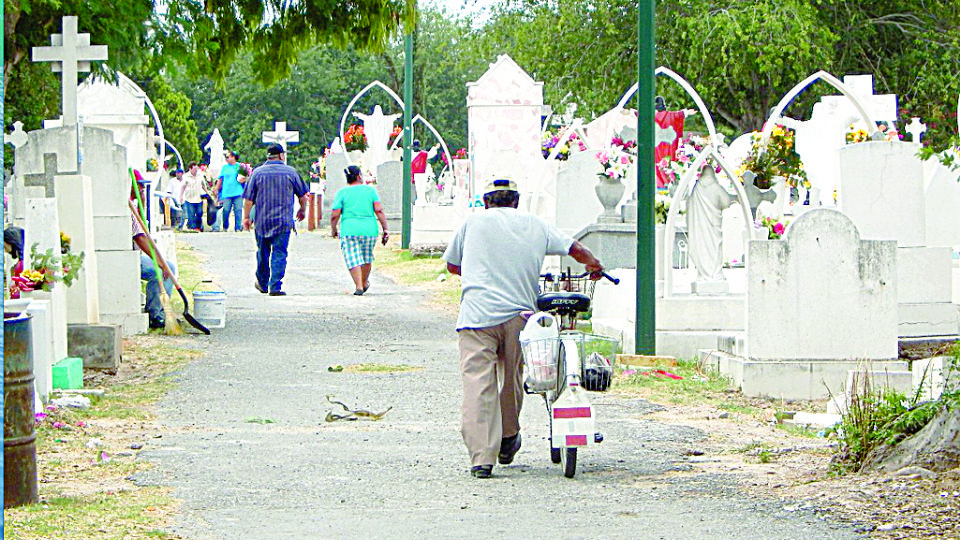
[687,164,735,288]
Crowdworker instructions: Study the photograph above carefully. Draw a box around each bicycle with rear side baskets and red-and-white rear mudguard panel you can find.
[520,270,620,478]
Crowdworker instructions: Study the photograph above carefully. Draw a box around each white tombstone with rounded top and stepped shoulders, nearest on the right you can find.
[732,208,904,399]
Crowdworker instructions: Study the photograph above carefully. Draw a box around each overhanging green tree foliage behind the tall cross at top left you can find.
[4,0,405,130]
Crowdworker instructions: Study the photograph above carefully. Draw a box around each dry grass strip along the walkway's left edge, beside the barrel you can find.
[3,246,205,540]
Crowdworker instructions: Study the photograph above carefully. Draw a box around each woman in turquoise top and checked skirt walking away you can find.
[330,165,390,296]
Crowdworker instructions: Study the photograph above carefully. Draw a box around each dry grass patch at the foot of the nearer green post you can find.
[613,360,732,405]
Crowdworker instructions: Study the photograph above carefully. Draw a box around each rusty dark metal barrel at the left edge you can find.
[3,313,37,508]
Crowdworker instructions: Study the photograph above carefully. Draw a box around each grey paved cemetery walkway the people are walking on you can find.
[138,233,858,540]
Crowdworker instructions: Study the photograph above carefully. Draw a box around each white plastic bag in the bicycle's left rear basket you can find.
[520,311,560,392]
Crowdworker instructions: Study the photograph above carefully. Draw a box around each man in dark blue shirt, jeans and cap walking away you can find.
[243,144,307,296]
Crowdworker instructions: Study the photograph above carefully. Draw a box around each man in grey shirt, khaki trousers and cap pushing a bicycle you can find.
[443,177,603,478]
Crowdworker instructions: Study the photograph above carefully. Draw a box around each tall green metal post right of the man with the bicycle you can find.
[634,0,657,355]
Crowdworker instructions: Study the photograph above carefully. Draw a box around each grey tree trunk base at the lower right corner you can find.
[863,407,960,472]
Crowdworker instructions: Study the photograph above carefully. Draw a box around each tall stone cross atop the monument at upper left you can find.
[32,17,107,126]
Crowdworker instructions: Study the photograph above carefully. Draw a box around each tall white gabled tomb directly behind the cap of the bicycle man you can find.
[467,54,543,199]
